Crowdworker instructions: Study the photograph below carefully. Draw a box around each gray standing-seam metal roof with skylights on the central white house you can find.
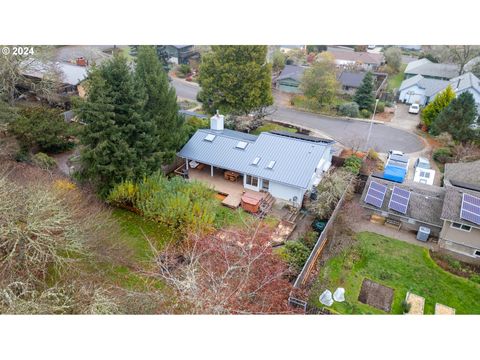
[178,129,331,189]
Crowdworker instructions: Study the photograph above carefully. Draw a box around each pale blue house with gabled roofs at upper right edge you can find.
[399,73,480,109]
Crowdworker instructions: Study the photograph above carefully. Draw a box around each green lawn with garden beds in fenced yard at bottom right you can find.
[311,232,480,314]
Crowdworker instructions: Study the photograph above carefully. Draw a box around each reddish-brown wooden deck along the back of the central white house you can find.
[188,166,265,209]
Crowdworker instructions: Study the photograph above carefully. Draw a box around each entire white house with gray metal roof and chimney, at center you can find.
[178,114,333,206]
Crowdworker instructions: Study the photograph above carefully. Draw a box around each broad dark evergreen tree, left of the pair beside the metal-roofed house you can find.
[75,54,158,196]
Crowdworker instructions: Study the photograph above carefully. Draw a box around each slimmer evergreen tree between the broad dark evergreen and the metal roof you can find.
[135,46,186,163]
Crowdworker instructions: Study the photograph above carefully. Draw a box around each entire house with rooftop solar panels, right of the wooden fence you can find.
[360,160,480,262]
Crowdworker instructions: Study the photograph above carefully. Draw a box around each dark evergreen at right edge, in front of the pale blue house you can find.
[430,91,479,143]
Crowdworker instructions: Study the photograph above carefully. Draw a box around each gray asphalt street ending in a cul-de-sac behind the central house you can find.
[172,78,424,153]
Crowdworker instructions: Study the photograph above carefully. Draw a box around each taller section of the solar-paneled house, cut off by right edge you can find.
[439,160,480,258]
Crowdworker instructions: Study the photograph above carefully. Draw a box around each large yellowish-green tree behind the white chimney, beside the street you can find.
[199,45,273,115]
